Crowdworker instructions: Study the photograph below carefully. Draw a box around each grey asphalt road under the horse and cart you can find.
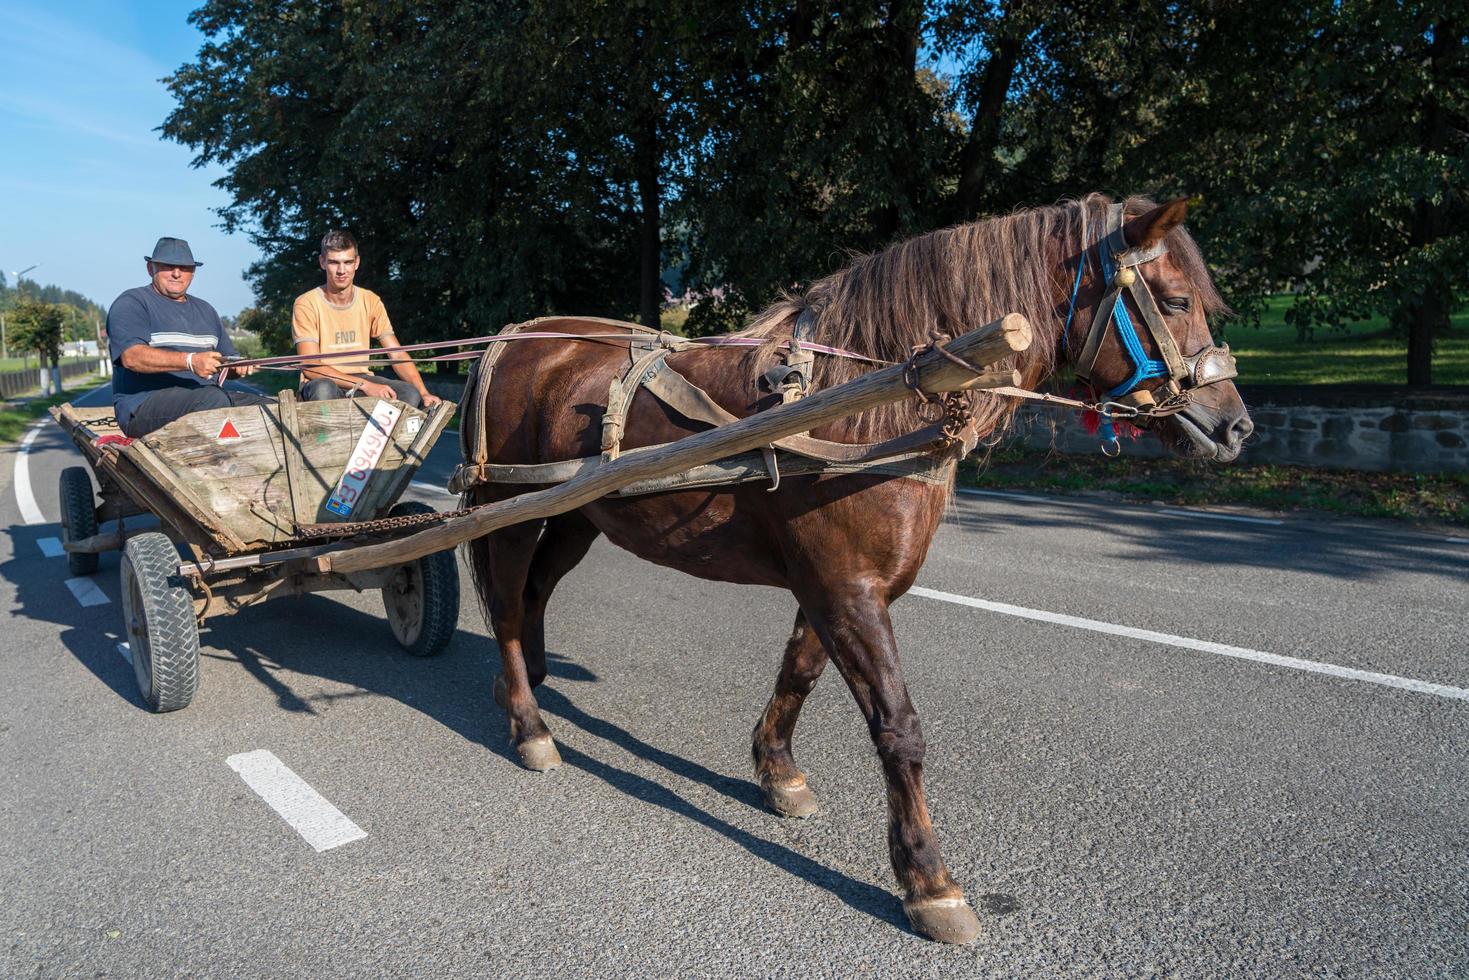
[0,382,1469,977]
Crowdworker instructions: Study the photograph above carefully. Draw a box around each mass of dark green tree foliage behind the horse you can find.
[165,0,1469,382]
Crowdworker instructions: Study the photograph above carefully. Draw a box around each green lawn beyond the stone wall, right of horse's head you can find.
[1224,295,1469,385]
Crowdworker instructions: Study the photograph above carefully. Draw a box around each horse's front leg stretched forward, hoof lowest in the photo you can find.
[802,585,980,943]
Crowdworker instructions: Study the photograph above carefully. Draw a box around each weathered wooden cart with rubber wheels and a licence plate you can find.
[51,391,460,711]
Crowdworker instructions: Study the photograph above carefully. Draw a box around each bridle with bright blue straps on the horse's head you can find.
[1062,204,1238,416]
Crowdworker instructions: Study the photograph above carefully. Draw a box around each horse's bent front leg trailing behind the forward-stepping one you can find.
[751,613,827,817]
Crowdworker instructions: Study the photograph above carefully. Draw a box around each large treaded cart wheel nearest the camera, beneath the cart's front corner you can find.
[122,530,198,711]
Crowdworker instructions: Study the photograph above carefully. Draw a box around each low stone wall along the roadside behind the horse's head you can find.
[1015,385,1469,473]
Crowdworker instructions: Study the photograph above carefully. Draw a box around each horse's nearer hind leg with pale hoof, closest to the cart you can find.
[474,522,561,773]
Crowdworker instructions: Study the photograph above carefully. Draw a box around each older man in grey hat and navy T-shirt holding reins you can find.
[107,238,273,438]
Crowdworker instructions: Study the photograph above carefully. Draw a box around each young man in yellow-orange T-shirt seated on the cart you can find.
[291,231,439,408]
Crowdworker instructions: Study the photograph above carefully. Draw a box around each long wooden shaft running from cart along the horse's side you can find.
[317,313,1031,572]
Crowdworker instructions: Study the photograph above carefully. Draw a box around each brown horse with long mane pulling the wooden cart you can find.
[463,195,1252,942]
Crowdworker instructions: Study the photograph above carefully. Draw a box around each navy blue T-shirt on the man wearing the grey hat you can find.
[107,285,235,429]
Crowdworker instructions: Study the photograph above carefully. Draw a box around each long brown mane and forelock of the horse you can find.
[740,194,1224,439]
